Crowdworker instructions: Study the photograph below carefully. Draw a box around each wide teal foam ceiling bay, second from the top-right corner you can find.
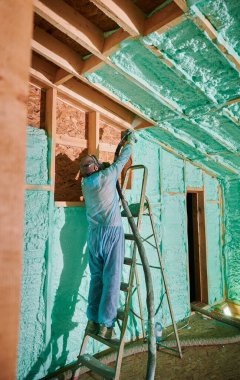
[144,20,240,103]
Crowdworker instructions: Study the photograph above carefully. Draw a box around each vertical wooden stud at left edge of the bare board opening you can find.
[46,88,57,187]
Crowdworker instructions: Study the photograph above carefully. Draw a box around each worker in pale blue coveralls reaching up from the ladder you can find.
[80,134,135,339]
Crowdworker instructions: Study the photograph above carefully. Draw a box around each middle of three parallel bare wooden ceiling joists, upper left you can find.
[34,0,104,52]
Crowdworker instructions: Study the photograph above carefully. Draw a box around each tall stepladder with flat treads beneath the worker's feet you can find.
[75,165,182,380]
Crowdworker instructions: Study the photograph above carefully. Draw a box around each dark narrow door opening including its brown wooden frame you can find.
[187,190,208,303]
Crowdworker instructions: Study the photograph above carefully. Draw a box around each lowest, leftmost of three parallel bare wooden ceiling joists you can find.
[32,27,83,75]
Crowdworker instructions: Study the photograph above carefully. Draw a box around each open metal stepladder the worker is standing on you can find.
[75,165,182,380]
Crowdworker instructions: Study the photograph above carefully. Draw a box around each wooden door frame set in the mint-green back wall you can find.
[186,188,208,304]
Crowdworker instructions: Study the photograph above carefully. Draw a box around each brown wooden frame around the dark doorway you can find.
[186,188,208,304]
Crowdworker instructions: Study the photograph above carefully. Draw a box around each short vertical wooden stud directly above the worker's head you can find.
[88,111,99,157]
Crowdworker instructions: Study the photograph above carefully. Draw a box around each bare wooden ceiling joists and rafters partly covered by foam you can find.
[30,0,240,180]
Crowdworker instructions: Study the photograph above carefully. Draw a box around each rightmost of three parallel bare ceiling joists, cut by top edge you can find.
[91,0,145,36]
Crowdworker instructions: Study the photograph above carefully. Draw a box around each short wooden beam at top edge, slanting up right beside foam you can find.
[144,3,186,35]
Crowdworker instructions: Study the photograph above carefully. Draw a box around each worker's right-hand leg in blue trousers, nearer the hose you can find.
[98,227,124,327]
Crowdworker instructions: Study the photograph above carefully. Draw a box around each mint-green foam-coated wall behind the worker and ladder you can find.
[18,127,228,379]
